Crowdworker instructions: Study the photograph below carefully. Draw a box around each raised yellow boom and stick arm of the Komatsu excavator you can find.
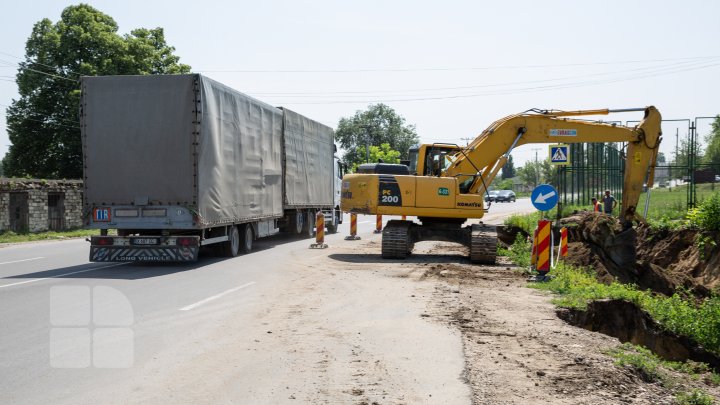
[443,106,661,222]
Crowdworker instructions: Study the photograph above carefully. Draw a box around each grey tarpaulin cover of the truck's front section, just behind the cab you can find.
[282,108,334,207]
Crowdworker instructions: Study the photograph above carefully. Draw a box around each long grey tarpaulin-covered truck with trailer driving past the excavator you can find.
[80,74,343,262]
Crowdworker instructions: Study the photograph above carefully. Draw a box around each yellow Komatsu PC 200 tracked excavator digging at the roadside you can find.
[341,106,662,264]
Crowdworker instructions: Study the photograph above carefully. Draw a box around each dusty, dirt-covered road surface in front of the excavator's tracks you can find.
[60,216,704,405]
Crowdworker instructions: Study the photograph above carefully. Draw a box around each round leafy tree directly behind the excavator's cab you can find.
[335,104,420,167]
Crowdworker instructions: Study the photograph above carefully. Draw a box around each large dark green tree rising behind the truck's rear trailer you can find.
[3,4,190,178]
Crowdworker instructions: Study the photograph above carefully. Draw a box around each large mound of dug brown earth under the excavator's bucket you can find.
[562,212,720,296]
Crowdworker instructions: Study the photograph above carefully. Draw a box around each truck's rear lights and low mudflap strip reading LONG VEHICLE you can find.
[90,236,200,262]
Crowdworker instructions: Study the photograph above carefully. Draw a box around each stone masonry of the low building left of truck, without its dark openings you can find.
[0,178,82,232]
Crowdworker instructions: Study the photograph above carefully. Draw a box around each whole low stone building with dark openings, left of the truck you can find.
[0,178,82,232]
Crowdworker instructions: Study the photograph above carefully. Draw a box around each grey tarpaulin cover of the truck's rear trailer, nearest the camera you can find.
[81,75,283,225]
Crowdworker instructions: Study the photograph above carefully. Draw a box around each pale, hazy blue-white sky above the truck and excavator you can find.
[0,0,720,166]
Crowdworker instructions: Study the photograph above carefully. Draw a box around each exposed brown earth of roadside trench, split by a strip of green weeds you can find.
[557,213,720,370]
